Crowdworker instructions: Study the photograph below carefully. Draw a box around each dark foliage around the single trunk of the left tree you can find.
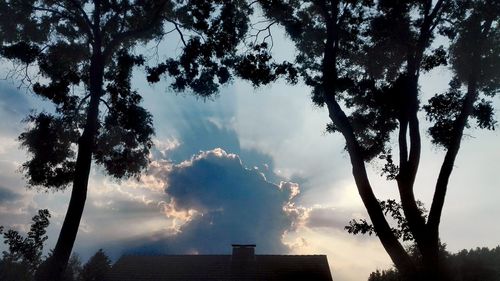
[0,0,209,189]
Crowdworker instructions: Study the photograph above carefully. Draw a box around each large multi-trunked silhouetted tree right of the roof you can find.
[235,0,500,280]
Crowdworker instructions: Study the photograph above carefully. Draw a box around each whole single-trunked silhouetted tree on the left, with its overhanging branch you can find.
[0,0,248,280]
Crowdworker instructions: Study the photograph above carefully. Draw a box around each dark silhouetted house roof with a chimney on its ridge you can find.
[107,245,332,281]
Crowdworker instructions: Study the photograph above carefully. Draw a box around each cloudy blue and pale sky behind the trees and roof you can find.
[0,26,500,281]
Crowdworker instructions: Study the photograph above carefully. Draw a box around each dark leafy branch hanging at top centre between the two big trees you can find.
[146,0,252,98]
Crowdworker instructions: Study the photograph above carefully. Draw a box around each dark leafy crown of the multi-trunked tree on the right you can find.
[252,0,500,162]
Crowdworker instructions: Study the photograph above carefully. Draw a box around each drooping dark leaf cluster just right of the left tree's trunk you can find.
[94,50,154,179]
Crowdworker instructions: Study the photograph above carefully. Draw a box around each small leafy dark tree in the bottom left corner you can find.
[0,210,50,281]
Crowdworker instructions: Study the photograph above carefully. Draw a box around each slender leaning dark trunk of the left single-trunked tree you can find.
[35,52,104,281]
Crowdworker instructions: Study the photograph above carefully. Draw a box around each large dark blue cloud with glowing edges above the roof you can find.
[122,149,298,254]
